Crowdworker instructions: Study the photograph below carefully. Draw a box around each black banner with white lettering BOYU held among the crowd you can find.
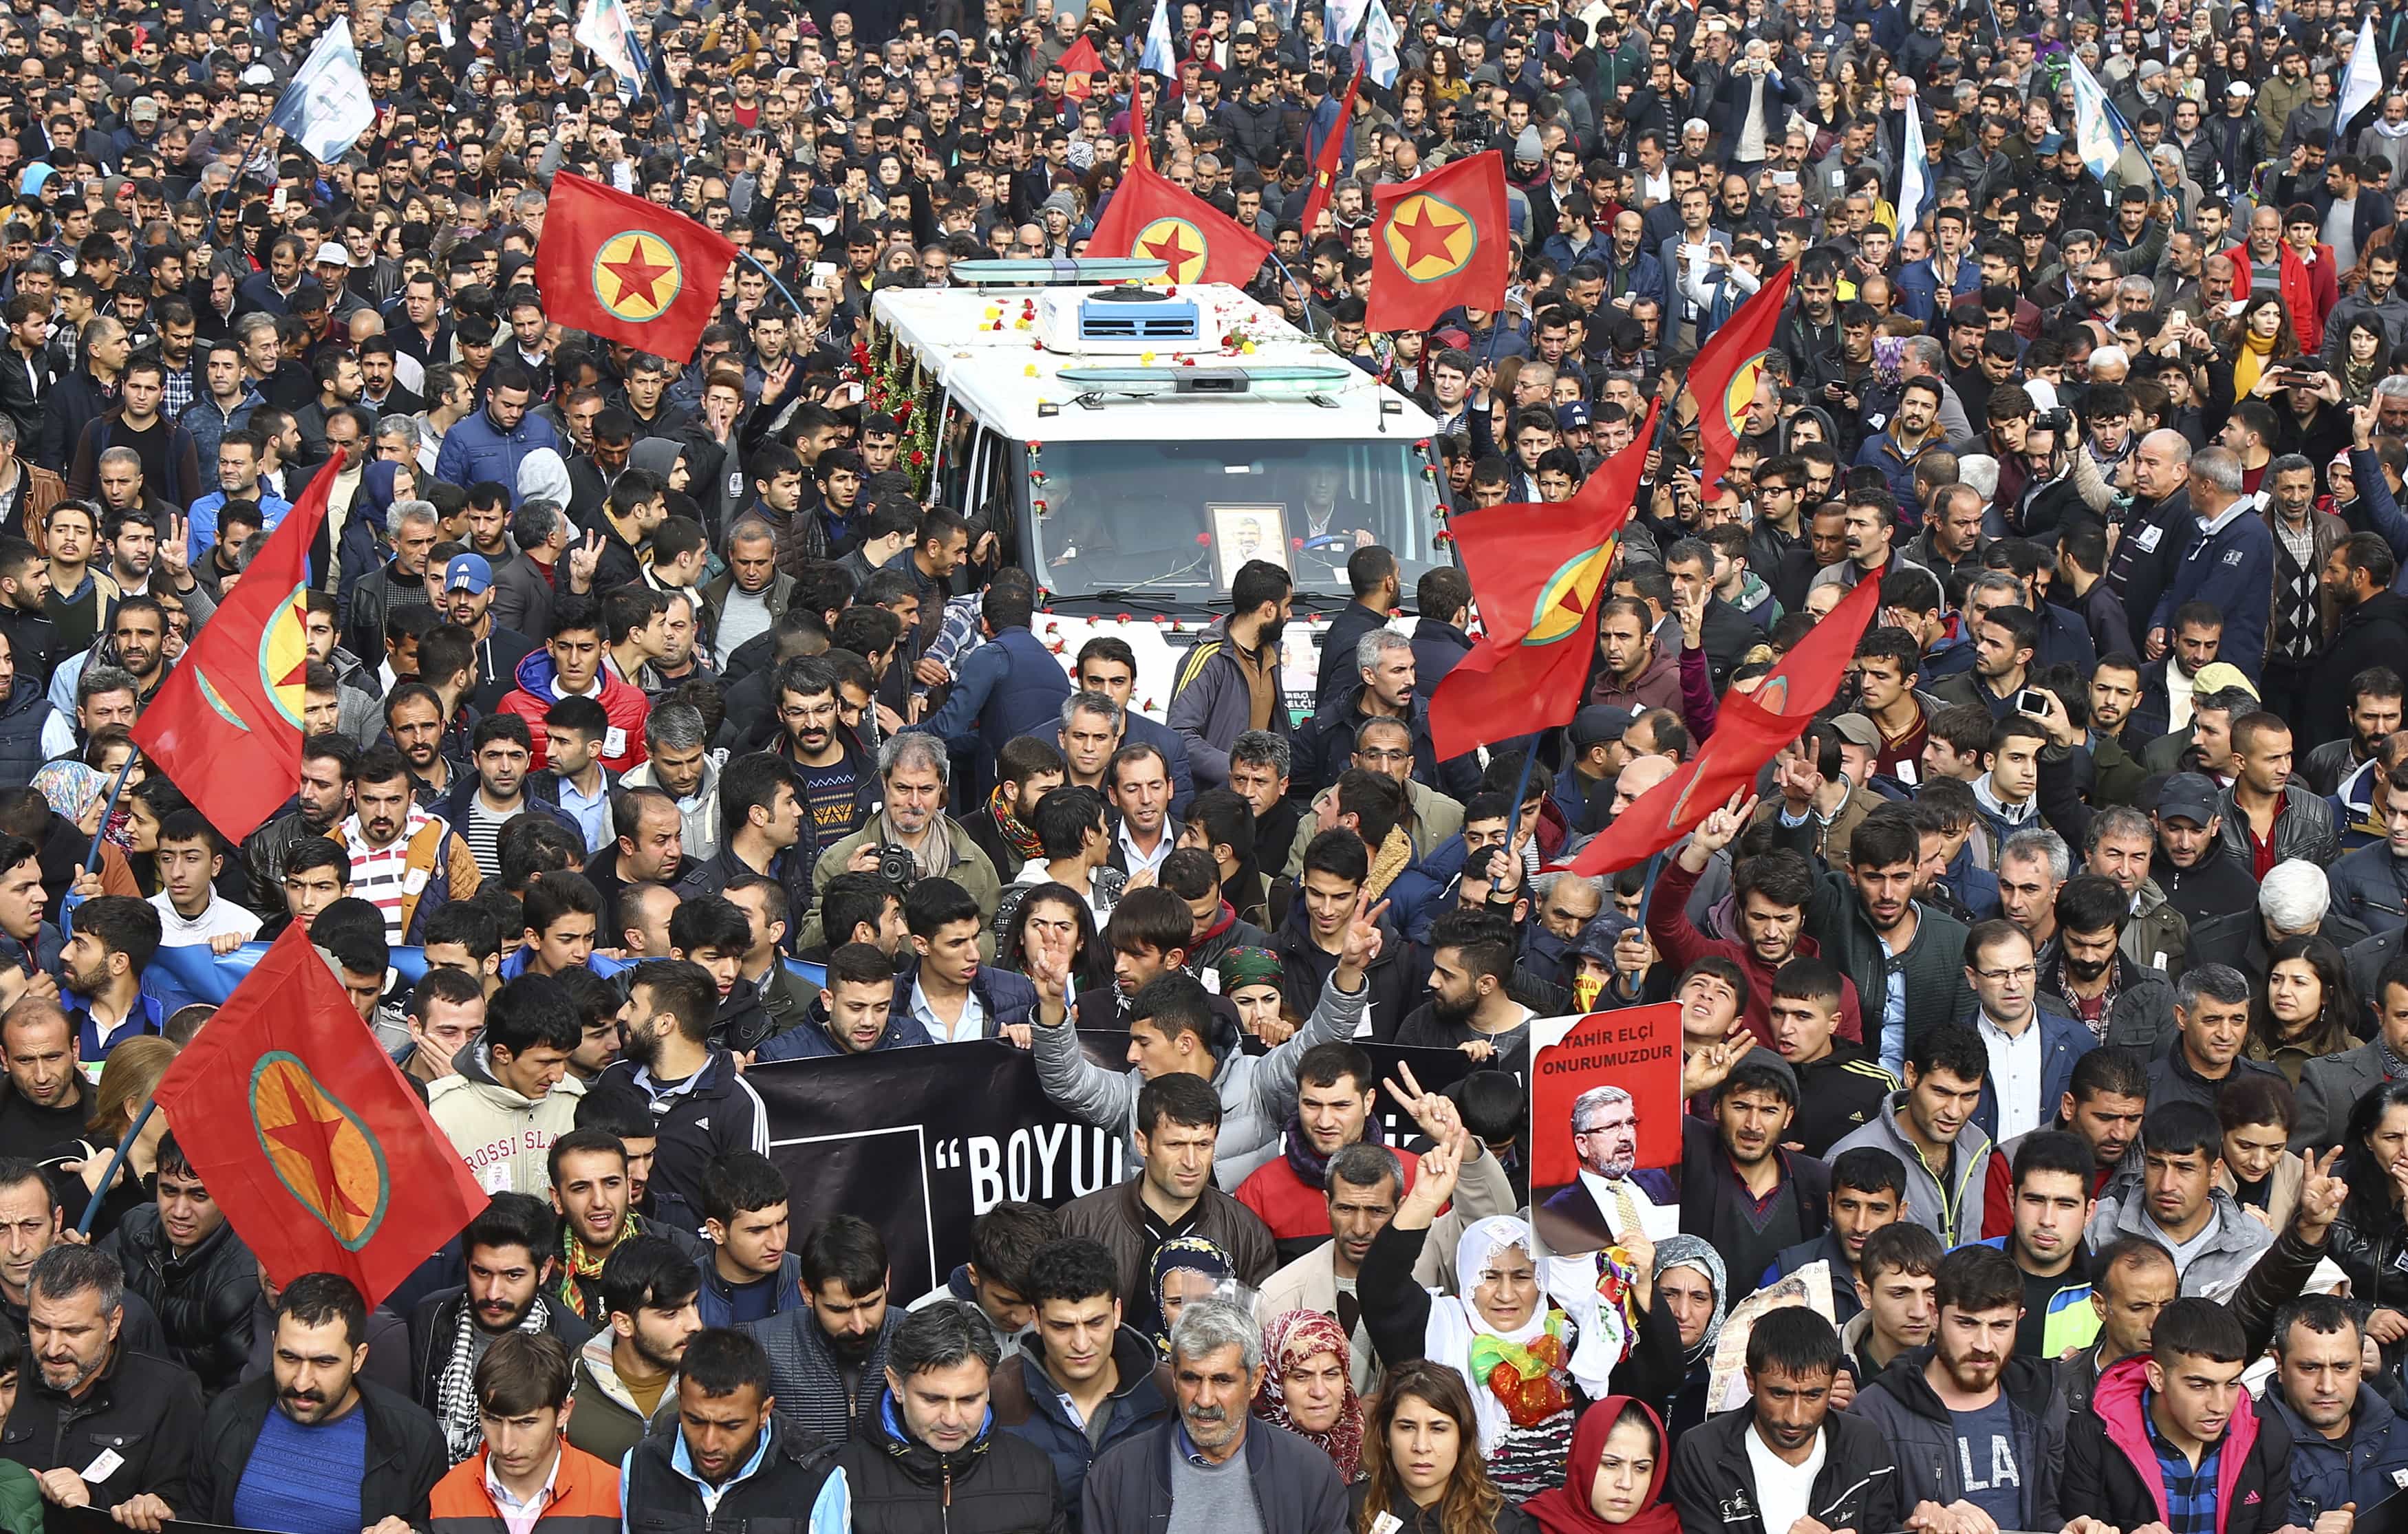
[744,1030,1472,1300]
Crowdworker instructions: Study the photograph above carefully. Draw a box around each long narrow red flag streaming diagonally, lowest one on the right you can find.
[1551,563,1881,876]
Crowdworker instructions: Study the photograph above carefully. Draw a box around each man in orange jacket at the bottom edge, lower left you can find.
[429,1332,619,1534]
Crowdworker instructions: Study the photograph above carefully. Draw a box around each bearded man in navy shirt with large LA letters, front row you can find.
[1849,1231,2081,1529]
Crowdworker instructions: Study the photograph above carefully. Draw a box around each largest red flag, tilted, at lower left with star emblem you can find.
[154,920,486,1308]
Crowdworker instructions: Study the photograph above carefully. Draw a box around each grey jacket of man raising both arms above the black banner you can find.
[1031,973,1370,1189]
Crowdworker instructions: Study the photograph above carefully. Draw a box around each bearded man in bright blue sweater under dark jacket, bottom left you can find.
[118,1274,443,1534]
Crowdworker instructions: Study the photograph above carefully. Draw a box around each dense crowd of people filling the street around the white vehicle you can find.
[0,0,2408,1534]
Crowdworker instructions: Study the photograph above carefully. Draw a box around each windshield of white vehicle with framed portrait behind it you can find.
[1029,438,1438,602]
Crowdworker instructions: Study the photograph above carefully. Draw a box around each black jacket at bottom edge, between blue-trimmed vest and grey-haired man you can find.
[836,1392,1064,1534]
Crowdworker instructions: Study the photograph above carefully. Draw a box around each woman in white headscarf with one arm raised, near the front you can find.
[1356,1146,1623,1502]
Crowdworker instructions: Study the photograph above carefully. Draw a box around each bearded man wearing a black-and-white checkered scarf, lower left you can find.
[409,1192,592,1469]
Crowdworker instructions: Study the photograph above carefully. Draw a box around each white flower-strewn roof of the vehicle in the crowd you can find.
[874,282,1438,446]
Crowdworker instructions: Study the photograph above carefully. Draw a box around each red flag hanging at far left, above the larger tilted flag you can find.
[133,470,335,841]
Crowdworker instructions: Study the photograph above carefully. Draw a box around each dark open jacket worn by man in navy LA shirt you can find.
[1849,1343,2066,1529]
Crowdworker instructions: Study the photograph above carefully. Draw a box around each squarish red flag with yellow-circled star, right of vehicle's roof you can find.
[1363,149,1510,330]
